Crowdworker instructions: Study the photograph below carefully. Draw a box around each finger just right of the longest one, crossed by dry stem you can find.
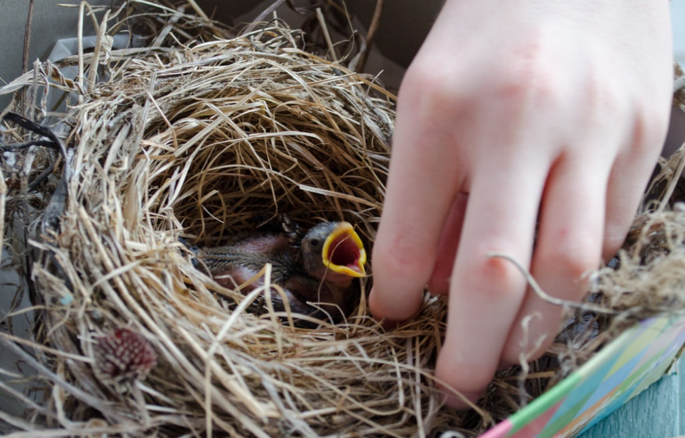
[502,156,609,364]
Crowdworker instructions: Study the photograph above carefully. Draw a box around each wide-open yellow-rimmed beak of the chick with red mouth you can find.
[322,222,366,277]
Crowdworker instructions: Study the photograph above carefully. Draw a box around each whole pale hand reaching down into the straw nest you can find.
[370,0,673,407]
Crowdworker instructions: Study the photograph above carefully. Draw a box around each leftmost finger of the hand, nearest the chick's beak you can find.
[369,84,463,321]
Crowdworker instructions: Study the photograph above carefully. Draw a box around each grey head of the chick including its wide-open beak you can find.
[300,222,366,286]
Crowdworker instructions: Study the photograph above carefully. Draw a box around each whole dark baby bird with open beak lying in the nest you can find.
[194,221,366,322]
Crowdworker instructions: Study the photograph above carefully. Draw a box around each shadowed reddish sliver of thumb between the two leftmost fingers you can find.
[428,193,468,294]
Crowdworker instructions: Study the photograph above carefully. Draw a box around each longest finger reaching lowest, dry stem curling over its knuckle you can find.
[436,151,549,407]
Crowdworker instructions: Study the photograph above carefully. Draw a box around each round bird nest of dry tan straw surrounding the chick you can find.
[0,2,685,436]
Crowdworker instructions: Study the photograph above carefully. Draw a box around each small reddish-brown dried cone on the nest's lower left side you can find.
[93,328,157,384]
